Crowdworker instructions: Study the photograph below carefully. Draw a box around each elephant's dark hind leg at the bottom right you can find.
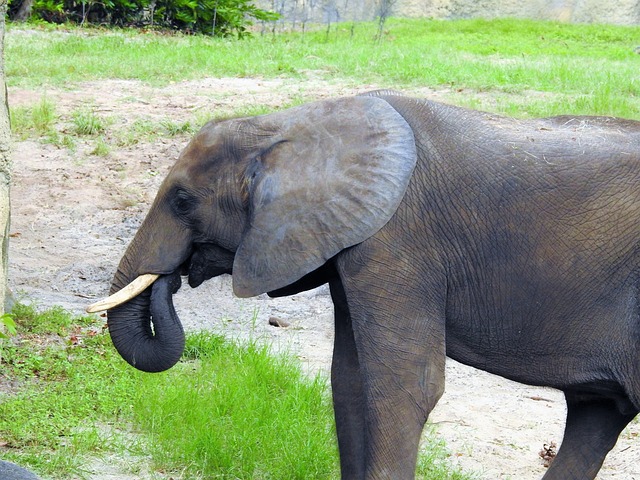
[543,393,637,480]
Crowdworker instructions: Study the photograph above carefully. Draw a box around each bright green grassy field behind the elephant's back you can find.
[6,19,640,118]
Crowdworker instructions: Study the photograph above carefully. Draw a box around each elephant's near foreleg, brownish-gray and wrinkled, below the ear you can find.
[340,248,445,480]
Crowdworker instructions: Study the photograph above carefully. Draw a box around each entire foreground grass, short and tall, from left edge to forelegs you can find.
[0,304,470,480]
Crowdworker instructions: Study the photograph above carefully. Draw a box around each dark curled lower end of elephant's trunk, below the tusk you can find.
[107,270,184,372]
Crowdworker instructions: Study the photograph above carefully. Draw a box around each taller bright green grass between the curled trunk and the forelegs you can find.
[135,334,339,480]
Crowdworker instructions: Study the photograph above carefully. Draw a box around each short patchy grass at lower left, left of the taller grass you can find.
[0,304,136,478]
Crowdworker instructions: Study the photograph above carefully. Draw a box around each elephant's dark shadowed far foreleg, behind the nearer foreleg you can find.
[329,279,365,480]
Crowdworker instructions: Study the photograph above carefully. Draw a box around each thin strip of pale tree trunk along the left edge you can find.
[0,0,11,322]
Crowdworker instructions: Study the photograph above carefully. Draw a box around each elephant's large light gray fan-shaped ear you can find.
[233,97,416,297]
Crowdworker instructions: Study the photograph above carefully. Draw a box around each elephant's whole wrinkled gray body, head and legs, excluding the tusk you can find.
[109,92,640,480]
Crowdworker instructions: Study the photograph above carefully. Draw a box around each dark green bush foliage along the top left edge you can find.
[9,0,278,37]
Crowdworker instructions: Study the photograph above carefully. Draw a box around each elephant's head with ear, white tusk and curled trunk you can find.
[90,97,416,371]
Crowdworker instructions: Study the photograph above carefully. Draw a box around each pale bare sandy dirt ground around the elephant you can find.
[9,77,640,480]
